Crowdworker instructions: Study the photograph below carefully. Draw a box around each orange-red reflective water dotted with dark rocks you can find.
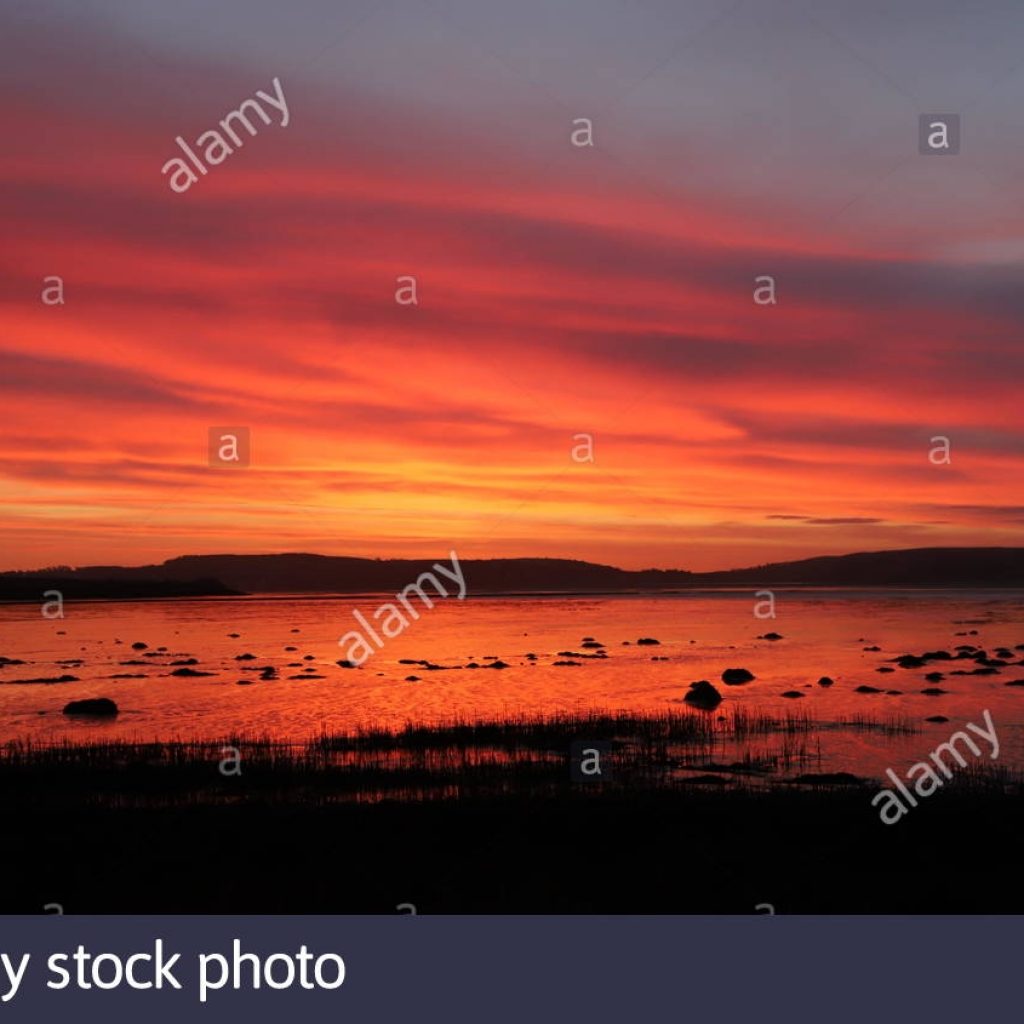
[0,591,1024,776]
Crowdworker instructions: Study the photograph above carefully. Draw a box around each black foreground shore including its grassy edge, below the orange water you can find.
[0,714,1024,913]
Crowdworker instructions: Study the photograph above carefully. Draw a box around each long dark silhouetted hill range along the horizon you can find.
[0,548,1024,600]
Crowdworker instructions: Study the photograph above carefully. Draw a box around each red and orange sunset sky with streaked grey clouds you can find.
[0,0,1024,570]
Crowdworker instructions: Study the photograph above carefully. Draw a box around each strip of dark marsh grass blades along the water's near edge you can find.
[0,708,929,807]
